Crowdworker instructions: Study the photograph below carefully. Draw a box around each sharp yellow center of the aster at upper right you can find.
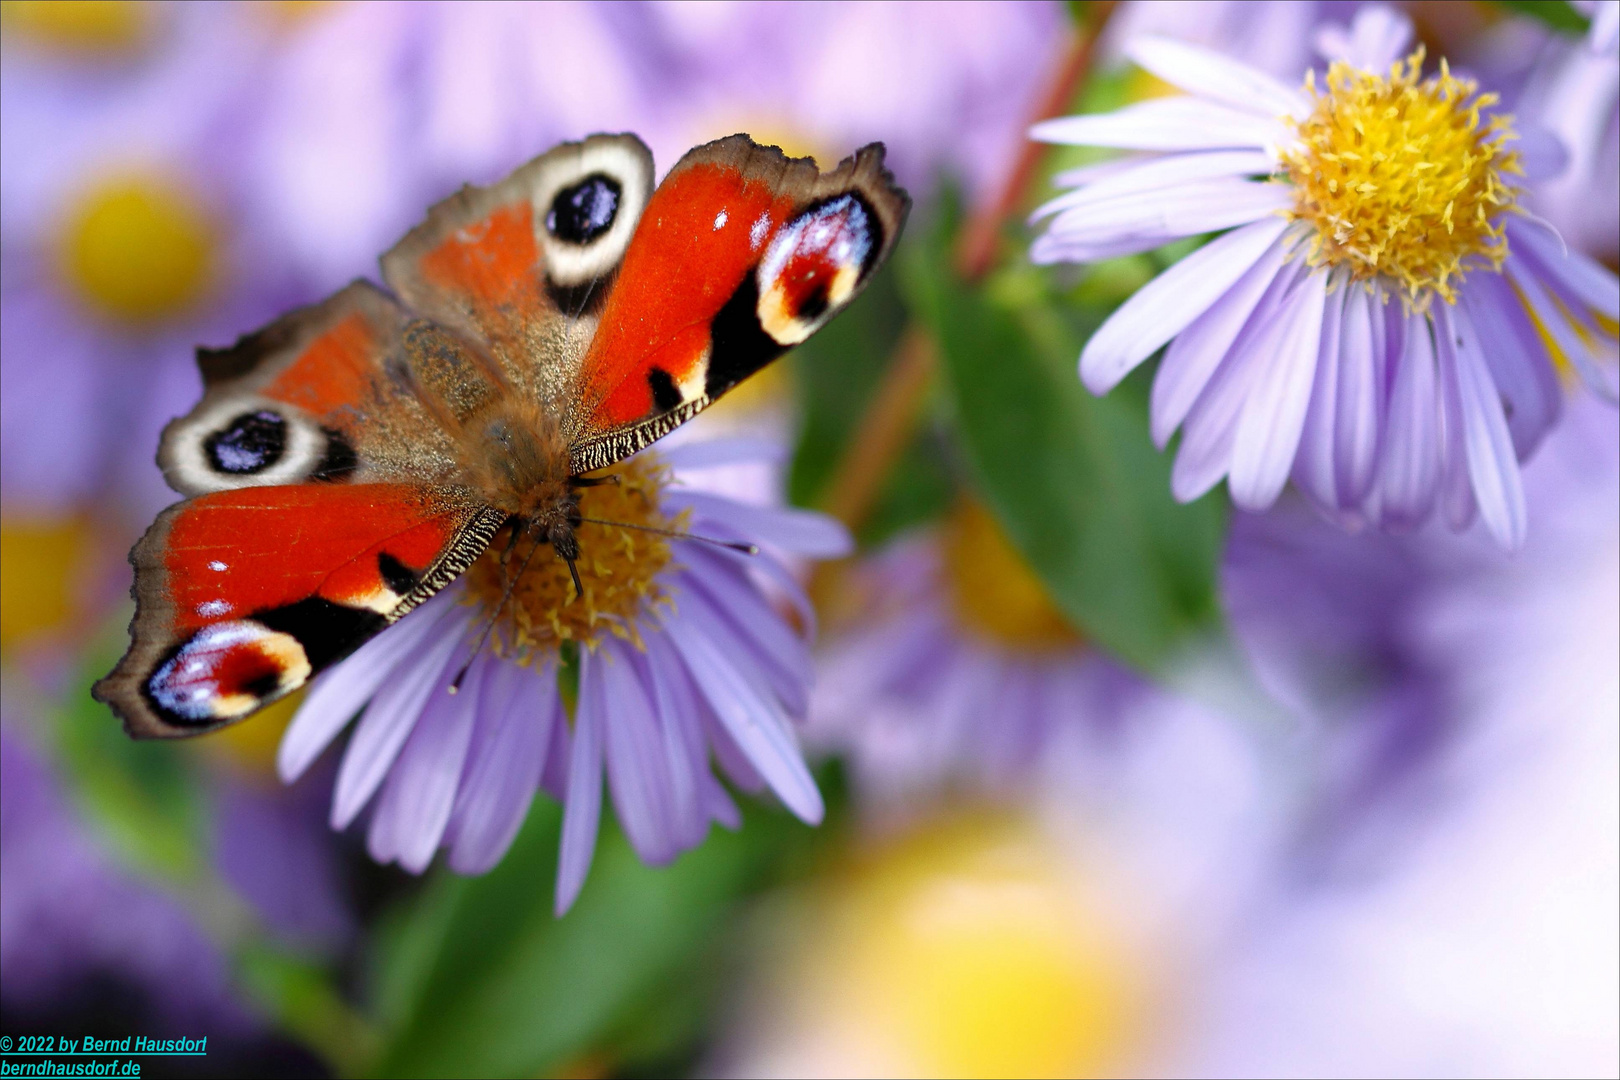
[1283,49,1523,311]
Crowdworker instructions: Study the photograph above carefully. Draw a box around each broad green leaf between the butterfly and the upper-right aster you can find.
[902,221,1225,672]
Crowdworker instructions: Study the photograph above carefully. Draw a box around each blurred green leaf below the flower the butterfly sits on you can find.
[376,798,812,1077]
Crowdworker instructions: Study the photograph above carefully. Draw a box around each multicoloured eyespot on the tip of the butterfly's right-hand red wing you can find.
[755,193,883,345]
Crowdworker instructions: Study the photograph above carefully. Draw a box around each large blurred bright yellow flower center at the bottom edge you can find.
[802,816,1150,1077]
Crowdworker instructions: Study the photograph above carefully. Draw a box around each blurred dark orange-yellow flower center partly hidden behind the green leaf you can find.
[944,499,1081,649]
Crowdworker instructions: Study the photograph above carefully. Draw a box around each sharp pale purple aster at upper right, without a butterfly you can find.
[1032,8,1620,547]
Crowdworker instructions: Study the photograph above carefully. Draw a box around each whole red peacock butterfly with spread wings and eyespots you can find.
[94,134,909,737]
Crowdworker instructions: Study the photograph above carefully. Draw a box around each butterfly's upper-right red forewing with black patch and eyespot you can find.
[565,134,909,471]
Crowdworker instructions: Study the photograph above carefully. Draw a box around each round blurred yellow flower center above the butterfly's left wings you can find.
[60,175,215,322]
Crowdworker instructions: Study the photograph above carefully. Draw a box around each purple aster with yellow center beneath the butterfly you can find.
[279,444,849,913]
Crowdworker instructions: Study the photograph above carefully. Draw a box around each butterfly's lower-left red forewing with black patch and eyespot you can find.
[96,484,505,737]
